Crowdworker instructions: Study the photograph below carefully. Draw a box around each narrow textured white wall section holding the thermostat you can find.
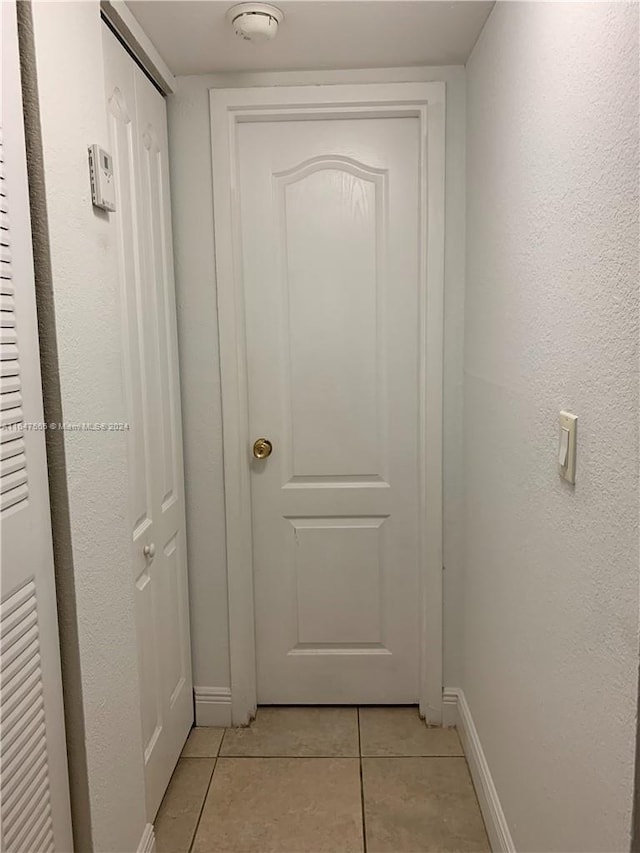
[33,0,146,853]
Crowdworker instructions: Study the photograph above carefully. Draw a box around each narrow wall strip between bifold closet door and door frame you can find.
[167,77,230,696]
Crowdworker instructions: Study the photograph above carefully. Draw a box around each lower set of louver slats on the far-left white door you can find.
[0,580,54,853]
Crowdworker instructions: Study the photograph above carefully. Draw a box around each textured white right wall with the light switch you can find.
[462,3,639,851]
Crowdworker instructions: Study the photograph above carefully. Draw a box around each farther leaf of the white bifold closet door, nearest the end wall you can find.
[135,61,193,800]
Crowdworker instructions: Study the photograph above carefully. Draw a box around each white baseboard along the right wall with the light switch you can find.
[442,687,516,853]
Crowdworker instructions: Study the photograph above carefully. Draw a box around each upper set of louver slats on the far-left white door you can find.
[0,128,29,515]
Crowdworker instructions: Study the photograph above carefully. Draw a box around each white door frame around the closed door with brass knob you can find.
[209,82,445,725]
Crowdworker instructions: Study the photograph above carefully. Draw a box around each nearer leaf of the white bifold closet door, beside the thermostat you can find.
[104,26,164,808]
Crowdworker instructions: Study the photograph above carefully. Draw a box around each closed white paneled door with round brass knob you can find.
[237,113,421,704]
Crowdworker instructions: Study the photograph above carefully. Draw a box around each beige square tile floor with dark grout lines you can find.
[155,707,490,853]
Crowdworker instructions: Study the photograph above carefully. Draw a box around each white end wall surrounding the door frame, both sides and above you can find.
[168,67,465,700]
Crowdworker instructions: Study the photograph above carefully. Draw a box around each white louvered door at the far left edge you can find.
[0,2,72,853]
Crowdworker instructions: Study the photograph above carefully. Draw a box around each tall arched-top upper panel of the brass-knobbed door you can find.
[275,157,386,482]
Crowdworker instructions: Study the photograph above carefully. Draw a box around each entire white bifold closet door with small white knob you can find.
[103,26,193,821]
